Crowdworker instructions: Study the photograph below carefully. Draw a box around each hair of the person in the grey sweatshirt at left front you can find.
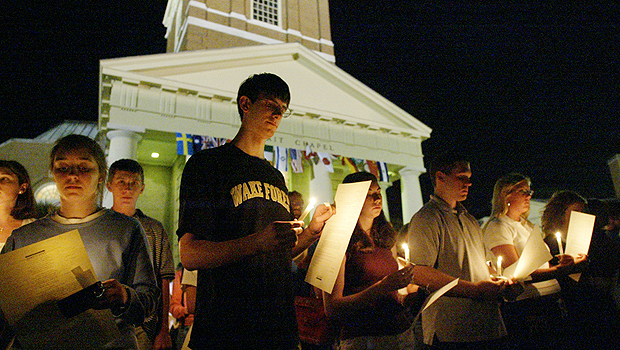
[50,134,108,200]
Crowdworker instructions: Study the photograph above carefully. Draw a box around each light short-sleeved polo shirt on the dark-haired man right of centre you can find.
[408,196,506,344]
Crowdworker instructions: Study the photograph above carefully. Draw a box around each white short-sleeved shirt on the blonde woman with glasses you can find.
[484,215,560,300]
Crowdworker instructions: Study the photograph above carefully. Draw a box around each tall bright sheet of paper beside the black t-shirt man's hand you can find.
[306,181,371,293]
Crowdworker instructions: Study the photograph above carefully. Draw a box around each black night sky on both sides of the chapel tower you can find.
[0,0,620,216]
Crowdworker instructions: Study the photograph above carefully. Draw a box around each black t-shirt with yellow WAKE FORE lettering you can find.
[177,144,298,349]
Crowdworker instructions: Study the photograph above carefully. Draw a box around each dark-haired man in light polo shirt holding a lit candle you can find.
[407,151,519,350]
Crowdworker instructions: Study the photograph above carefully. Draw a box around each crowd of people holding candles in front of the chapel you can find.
[0,73,620,350]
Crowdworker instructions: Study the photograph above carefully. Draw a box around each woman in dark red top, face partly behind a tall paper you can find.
[323,172,414,349]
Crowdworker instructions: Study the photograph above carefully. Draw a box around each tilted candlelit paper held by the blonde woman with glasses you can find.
[504,225,553,281]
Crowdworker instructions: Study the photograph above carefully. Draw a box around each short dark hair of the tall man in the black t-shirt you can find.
[237,73,291,120]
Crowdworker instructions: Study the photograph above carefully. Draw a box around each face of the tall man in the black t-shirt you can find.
[241,96,288,139]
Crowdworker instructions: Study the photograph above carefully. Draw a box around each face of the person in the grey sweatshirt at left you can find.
[52,150,103,204]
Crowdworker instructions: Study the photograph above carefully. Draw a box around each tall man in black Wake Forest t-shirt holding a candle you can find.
[177,73,333,349]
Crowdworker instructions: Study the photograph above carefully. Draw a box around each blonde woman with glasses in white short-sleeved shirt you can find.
[483,173,585,349]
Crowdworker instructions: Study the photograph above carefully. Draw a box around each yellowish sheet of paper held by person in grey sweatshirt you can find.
[0,230,120,349]
